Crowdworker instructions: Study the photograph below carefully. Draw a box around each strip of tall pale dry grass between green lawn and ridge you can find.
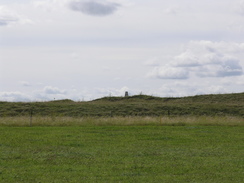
[0,116,244,127]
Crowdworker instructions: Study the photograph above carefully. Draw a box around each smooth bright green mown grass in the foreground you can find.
[0,125,244,183]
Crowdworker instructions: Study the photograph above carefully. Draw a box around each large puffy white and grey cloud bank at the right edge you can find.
[147,41,244,79]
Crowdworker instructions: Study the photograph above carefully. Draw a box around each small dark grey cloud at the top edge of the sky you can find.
[69,0,120,16]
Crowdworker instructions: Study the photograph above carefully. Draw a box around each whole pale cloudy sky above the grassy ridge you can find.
[0,0,244,101]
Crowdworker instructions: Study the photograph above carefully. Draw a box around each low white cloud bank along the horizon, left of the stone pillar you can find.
[0,86,132,102]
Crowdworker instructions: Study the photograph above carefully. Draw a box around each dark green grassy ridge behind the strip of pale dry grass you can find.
[0,93,244,117]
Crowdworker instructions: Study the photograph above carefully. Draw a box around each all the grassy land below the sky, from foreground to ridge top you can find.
[0,93,244,183]
